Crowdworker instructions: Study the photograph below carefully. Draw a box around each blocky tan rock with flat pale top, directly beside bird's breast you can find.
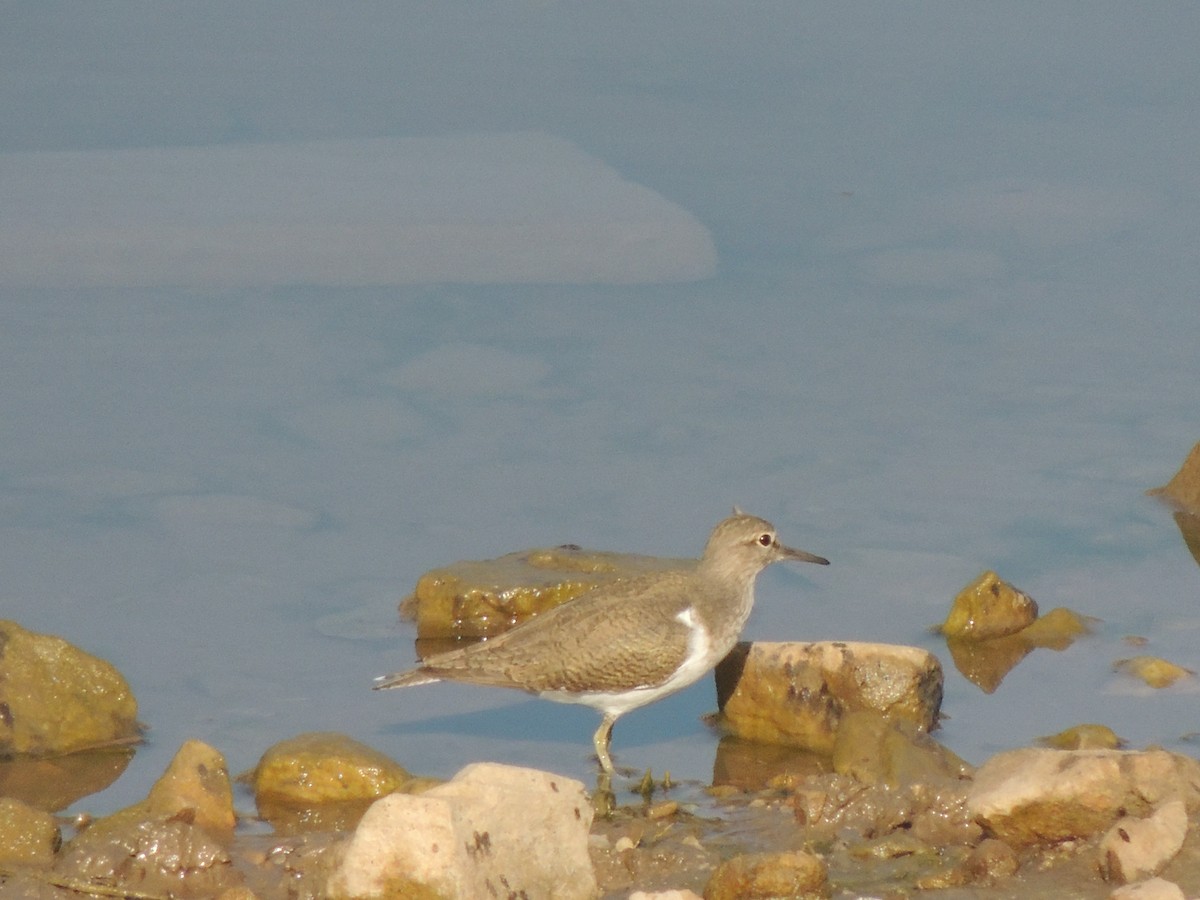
[715,641,942,754]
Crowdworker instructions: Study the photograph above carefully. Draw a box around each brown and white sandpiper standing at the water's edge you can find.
[374,508,829,774]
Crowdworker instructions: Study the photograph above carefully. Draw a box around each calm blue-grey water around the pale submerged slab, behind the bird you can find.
[0,2,1200,811]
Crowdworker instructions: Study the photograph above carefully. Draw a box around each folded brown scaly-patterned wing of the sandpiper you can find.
[406,572,690,694]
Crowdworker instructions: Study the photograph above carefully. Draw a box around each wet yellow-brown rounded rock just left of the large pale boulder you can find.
[252,732,414,834]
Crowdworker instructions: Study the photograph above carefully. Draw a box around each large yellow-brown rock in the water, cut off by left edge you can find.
[0,619,140,756]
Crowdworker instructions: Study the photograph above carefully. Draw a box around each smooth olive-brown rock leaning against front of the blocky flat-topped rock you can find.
[833,710,971,787]
